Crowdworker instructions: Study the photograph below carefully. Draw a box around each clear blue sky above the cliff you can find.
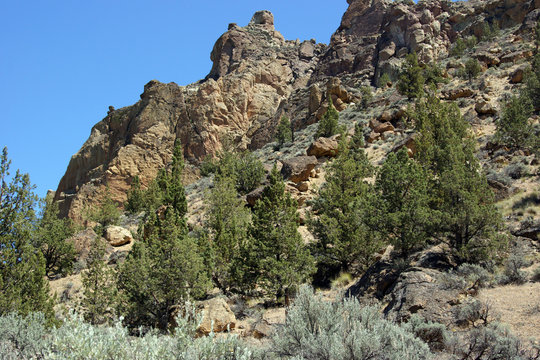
[0,0,347,196]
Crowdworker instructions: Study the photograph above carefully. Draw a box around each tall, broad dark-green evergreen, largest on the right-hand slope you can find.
[412,97,500,260]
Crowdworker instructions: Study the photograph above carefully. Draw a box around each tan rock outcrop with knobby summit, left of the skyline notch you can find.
[55,11,325,221]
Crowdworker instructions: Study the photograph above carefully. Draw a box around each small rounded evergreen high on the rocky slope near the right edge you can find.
[495,95,535,148]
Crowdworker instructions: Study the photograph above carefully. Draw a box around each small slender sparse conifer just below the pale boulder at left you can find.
[82,237,118,325]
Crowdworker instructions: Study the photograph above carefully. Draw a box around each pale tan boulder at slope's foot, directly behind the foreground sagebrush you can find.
[197,298,236,335]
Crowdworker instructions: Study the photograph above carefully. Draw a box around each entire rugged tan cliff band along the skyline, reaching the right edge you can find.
[55,0,540,220]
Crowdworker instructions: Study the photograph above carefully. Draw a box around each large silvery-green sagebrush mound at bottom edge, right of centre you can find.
[270,286,431,360]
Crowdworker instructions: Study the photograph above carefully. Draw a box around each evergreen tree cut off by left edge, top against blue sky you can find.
[0,148,54,320]
